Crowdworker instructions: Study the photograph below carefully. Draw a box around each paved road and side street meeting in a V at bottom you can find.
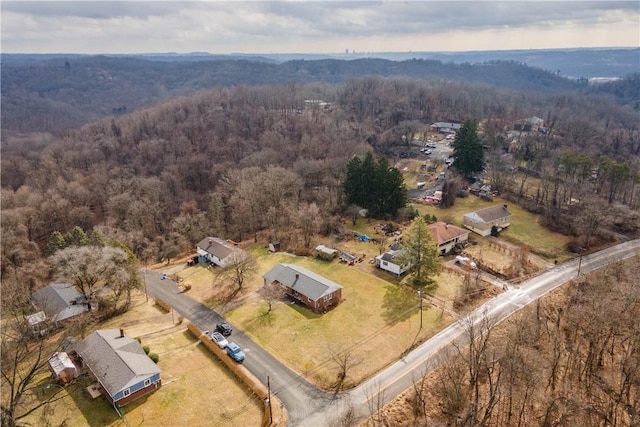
[145,240,640,427]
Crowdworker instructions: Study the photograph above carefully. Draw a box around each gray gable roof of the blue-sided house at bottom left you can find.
[76,329,161,397]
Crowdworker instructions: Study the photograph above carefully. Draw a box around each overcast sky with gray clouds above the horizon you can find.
[1,0,640,53]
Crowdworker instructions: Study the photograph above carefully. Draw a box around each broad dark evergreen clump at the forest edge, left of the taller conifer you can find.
[344,152,407,217]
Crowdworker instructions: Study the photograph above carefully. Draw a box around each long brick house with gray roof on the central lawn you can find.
[263,264,342,313]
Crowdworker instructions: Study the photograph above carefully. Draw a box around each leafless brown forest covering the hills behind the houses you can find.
[1,57,640,310]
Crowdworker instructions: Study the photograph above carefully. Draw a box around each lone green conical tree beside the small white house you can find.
[398,216,440,292]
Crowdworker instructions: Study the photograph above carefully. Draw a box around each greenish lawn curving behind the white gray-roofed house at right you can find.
[415,196,571,261]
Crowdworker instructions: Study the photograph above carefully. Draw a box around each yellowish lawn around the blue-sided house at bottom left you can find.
[21,295,262,426]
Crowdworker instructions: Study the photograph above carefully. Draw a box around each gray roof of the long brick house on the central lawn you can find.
[263,264,342,301]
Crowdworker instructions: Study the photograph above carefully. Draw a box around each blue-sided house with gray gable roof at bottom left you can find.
[75,329,162,407]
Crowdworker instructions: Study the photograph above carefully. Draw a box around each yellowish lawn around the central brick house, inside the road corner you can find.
[226,254,451,387]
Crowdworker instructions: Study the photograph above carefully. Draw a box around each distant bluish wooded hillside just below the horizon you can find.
[2,55,580,133]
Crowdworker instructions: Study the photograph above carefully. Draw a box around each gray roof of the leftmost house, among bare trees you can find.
[31,283,87,320]
